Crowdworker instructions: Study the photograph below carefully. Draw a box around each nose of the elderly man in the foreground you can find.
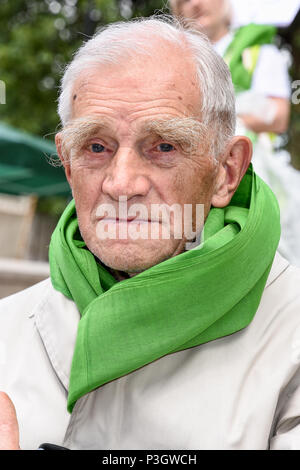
[102,147,151,201]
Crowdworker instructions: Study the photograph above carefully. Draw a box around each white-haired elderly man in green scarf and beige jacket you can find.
[0,18,300,449]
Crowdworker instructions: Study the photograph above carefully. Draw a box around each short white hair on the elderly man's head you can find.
[58,15,236,156]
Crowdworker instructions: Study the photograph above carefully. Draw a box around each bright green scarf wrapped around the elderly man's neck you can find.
[49,166,280,412]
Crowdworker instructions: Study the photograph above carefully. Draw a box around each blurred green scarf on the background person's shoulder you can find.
[224,23,276,93]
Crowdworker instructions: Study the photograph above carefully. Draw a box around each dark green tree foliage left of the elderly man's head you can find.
[0,0,164,138]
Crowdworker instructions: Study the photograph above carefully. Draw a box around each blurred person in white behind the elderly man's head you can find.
[170,0,300,266]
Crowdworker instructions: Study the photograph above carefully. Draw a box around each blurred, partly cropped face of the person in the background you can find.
[179,0,226,39]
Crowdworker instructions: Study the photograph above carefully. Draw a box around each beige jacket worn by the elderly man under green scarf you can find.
[0,255,300,450]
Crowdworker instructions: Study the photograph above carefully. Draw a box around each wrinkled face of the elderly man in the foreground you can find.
[59,46,223,274]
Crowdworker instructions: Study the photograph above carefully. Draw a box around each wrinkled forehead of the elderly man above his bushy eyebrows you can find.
[71,44,202,116]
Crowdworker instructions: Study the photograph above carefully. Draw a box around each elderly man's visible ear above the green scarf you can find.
[212,136,252,207]
